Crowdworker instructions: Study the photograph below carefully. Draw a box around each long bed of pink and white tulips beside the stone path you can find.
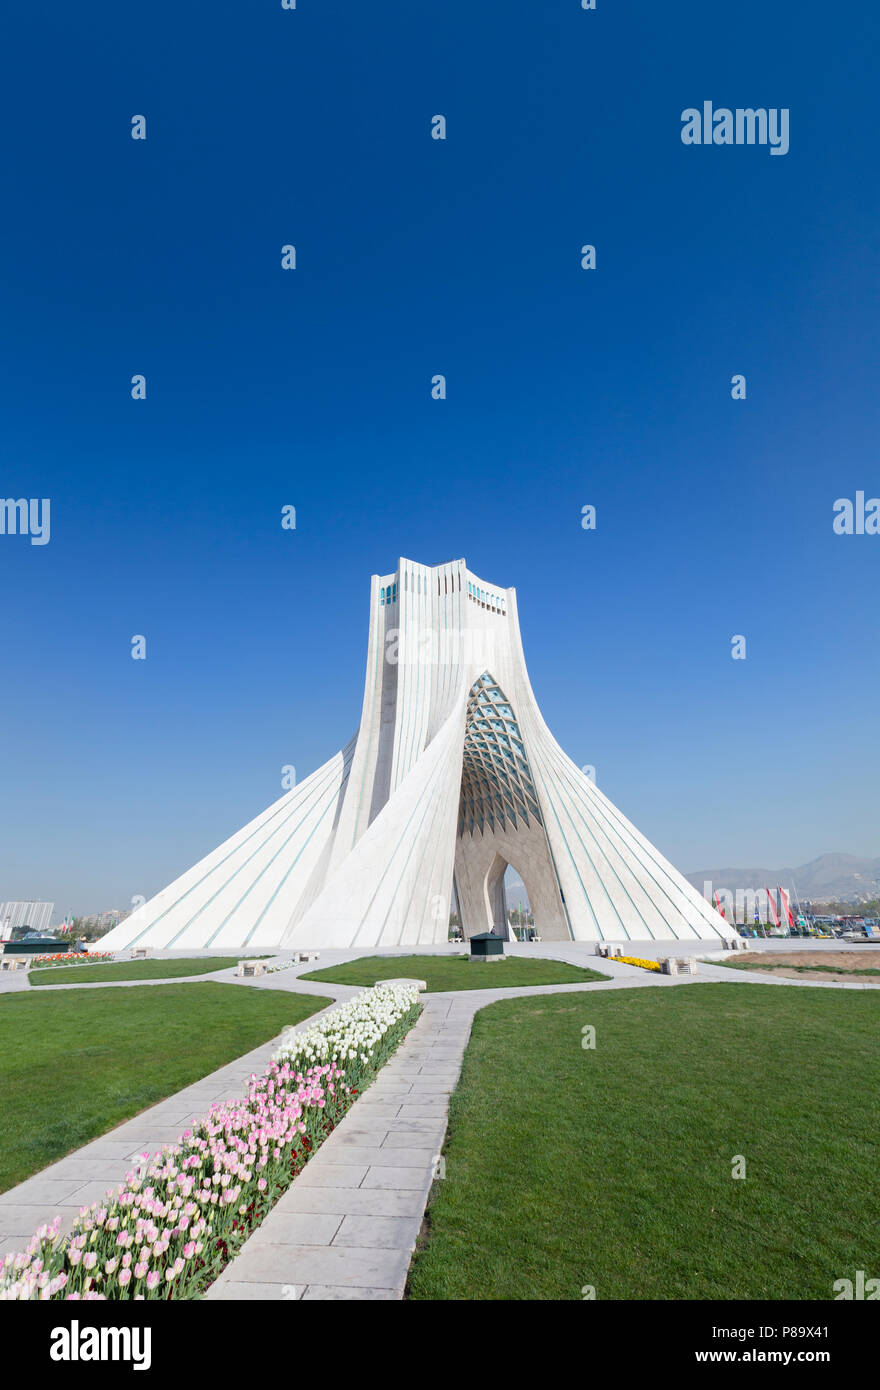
[0,986,420,1300]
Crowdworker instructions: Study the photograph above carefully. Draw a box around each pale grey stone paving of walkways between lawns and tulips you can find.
[0,941,880,1300]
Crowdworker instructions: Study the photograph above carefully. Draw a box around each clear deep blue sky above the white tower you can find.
[0,0,880,915]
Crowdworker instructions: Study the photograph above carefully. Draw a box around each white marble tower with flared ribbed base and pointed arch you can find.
[101,560,726,949]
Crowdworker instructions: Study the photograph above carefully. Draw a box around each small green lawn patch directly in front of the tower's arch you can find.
[300,955,608,994]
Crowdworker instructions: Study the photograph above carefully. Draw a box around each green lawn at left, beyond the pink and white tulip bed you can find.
[0,983,331,1191]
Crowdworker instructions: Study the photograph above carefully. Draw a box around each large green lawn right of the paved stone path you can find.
[409,983,880,1300]
